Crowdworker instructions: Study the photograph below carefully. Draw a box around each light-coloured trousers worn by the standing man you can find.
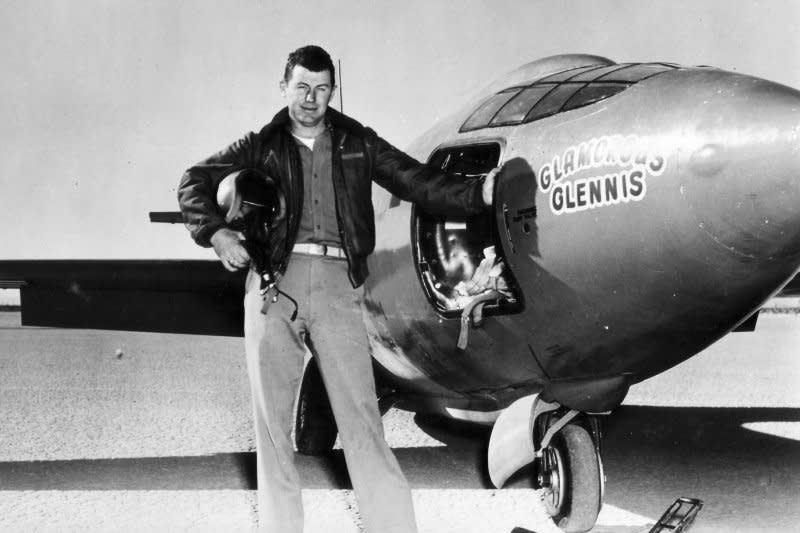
[244,254,417,533]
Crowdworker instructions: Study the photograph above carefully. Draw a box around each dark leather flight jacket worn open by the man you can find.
[178,108,488,288]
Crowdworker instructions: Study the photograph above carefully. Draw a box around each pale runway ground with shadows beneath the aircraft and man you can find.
[0,312,800,533]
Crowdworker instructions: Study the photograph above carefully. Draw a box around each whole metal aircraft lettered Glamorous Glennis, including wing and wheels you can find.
[0,55,800,531]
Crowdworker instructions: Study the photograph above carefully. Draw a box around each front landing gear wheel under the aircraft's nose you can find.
[538,424,603,533]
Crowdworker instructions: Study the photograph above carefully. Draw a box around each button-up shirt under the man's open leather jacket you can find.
[294,128,341,247]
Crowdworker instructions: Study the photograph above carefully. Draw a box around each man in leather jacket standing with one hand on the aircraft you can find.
[178,46,497,533]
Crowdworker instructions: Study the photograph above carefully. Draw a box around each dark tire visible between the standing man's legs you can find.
[294,358,338,455]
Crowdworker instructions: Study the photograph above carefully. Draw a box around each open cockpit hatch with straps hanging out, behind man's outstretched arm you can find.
[411,142,522,318]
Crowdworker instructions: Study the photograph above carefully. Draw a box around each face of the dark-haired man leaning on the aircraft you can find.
[281,65,334,128]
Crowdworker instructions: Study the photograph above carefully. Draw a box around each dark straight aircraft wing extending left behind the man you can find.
[0,260,246,336]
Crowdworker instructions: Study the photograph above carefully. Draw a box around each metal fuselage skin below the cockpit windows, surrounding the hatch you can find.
[365,61,800,411]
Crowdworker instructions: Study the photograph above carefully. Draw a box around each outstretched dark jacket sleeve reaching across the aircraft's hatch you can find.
[367,129,489,216]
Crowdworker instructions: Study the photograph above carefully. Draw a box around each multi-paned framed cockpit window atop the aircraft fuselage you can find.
[459,63,681,132]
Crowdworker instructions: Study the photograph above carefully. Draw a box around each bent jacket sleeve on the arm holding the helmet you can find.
[178,133,256,248]
